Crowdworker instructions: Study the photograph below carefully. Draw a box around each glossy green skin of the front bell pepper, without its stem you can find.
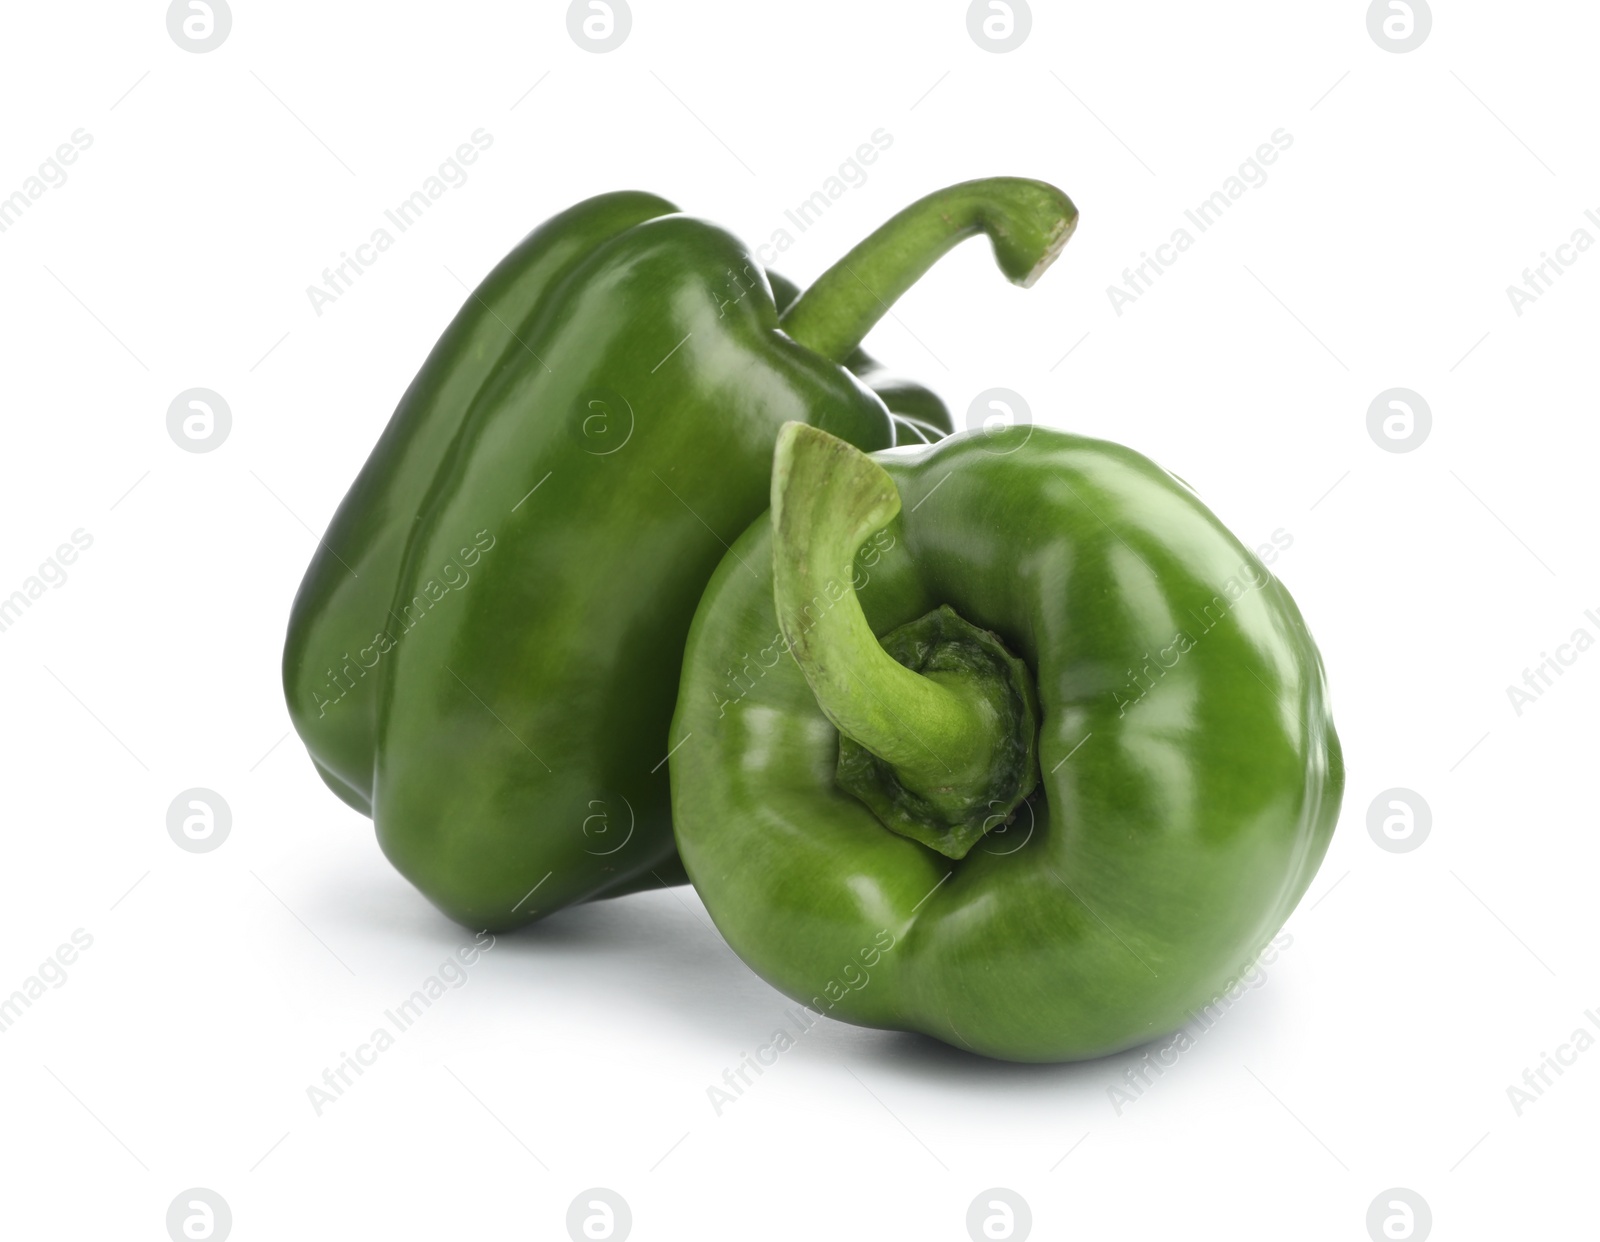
[672,427,1344,1061]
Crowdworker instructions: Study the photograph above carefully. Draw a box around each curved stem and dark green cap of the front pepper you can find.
[773,423,1037,858]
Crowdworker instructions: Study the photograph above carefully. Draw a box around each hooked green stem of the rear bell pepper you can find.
[779,176,1078,362]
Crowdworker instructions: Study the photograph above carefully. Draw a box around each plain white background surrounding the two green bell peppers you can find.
[0,0,1600,1242]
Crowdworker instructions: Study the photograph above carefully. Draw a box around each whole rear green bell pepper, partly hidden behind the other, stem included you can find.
[283,178,1075,930]
